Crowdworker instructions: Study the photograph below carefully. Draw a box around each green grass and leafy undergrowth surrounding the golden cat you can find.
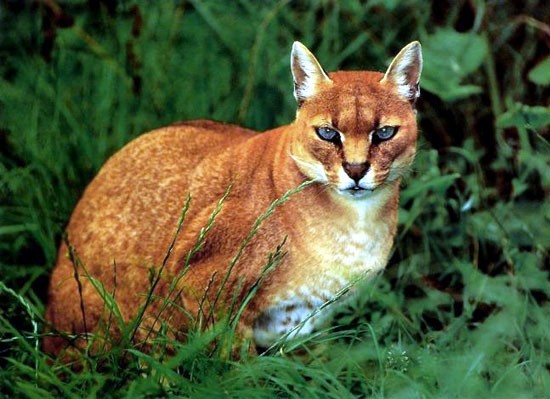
[0,0,550,398]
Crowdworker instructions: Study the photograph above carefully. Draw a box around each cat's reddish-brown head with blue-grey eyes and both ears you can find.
[291,42,422,199]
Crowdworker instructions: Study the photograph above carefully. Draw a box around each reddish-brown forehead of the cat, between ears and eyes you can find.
[302,71,413,132]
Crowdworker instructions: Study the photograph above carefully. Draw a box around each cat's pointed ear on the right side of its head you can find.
[382,42,422,104]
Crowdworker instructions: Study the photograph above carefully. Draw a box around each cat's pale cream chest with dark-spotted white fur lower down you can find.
[254,208,392,346]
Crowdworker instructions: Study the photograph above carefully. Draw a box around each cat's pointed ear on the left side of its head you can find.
[290,42,332,106]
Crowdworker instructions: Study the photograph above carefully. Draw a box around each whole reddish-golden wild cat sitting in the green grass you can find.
[44,42,422,354]
